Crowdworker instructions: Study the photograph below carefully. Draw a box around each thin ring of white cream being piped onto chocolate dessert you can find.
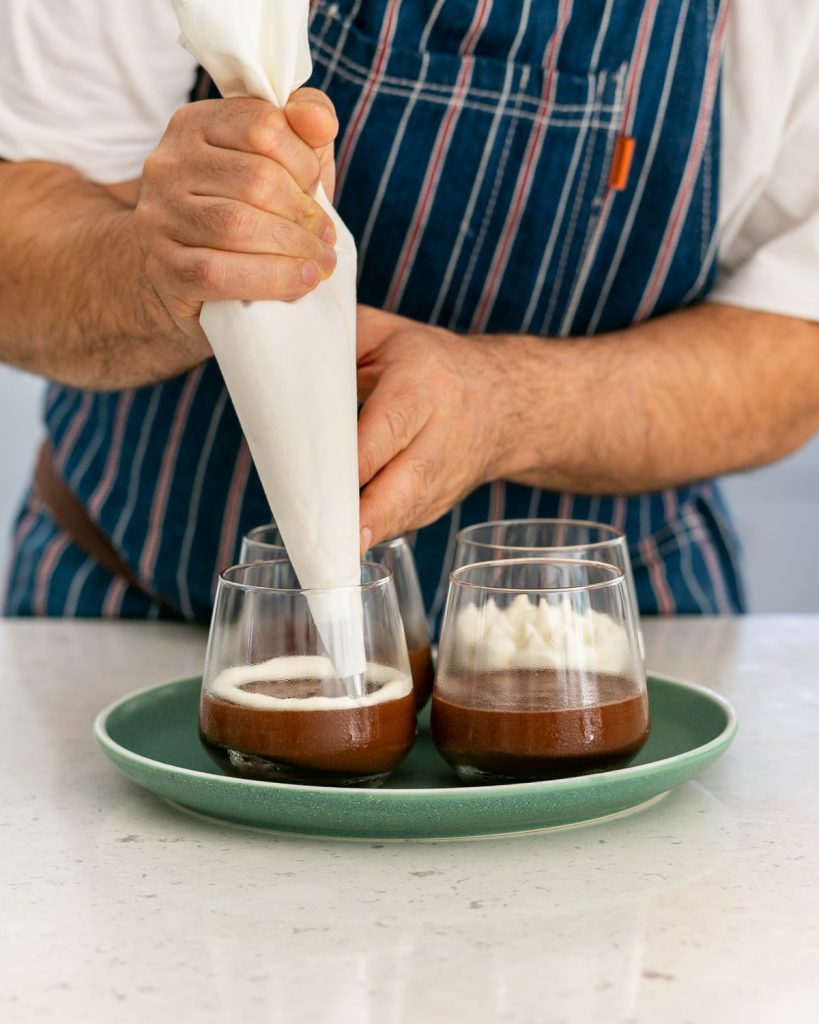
[207,655,413,711]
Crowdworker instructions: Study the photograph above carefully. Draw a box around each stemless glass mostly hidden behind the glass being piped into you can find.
[240,523,434,710]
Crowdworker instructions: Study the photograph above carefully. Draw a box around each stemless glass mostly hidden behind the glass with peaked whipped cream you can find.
[452,519,645,660]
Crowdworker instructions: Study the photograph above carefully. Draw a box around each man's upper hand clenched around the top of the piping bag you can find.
[134,89,338,339]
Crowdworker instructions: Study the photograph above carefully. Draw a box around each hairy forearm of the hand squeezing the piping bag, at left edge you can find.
[0,162,208,390]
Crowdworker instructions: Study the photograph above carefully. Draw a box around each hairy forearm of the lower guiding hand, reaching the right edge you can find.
[487,304,819,494]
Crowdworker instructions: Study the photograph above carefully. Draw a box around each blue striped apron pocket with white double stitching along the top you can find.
[310,4,626,332]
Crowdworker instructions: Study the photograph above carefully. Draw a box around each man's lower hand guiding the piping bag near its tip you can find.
[358,306,511,551]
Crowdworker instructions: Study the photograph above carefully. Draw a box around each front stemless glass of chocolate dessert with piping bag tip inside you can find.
[200,559,416,786]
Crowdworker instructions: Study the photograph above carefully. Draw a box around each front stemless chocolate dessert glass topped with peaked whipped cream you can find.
[432,558,649,783]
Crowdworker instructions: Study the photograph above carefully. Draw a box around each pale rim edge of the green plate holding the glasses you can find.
[93,672,739,802]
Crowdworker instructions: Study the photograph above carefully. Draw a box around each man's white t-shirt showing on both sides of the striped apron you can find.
[0,0,819,321]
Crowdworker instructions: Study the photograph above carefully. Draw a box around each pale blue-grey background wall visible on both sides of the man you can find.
[0,367,819,611]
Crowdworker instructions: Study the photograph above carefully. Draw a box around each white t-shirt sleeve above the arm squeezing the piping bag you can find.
[0,0,197,184]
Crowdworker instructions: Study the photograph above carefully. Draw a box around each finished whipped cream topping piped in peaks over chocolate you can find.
[447,594,639,675]
